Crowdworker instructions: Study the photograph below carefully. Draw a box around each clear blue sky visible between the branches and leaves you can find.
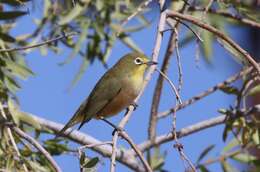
[10,3,246,172]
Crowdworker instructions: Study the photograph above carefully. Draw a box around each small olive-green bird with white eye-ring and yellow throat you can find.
[57,52,157,136]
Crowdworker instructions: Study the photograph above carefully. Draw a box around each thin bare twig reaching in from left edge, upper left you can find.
[0,32,78,53]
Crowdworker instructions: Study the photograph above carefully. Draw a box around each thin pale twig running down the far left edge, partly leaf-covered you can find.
[0,103,29,172]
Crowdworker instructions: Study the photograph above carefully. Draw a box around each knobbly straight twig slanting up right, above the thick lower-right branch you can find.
[158,67,253,118]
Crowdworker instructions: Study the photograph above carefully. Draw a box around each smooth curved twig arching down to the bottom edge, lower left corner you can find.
[12,127,61,172]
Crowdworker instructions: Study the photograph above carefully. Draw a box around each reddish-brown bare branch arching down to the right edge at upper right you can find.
[166,10,260,75]
